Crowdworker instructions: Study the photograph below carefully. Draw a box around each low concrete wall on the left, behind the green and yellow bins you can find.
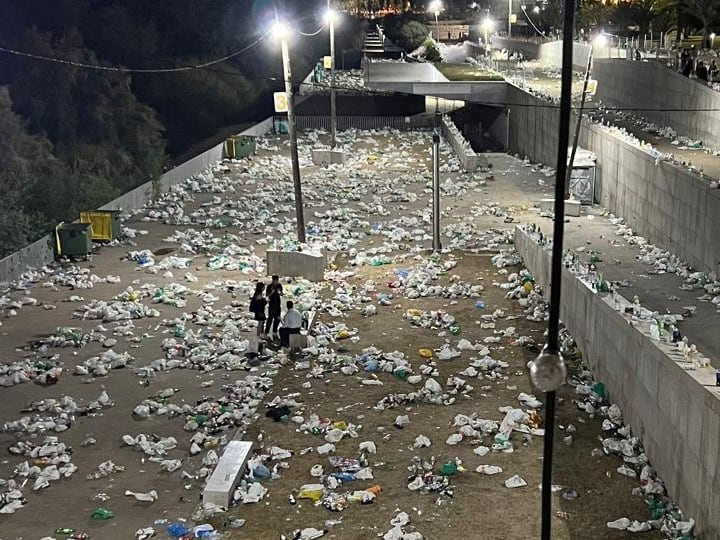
[0,117,272,282]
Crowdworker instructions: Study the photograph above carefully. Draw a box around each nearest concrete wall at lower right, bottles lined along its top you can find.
[515,229,720,540]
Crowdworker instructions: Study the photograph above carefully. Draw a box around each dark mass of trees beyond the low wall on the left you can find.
[0,0,362,256]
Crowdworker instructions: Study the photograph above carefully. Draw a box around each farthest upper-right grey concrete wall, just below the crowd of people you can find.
[593,60,720,149]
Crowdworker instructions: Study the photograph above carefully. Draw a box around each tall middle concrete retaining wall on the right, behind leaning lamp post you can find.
[508,86,720,272]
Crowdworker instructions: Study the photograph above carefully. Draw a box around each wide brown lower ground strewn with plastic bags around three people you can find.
[0,127,682,539]
